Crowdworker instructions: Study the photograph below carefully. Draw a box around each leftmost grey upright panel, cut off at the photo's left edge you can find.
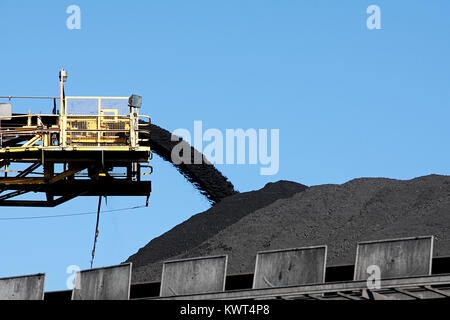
[0,274,45,300]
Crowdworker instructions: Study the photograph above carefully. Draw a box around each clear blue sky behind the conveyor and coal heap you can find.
[0,0,450,290]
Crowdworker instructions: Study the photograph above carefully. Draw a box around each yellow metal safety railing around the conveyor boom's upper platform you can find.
[0,96,150,148]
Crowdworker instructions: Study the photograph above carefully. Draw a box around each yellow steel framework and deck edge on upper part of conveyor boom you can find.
[0,96,150,153]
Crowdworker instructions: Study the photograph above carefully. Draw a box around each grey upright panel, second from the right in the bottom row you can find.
[253,246,327,289]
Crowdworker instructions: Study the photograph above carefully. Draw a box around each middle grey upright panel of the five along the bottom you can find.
[160,256,228,297]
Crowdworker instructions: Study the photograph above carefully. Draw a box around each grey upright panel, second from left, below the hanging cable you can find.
[72,263,132,300]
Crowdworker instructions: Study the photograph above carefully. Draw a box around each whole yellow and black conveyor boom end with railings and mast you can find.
[0,69,152,207]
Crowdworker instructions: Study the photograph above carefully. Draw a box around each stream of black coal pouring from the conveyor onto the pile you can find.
[141,124,237,204]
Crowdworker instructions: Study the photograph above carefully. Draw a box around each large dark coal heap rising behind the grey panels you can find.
[128,175,450,282]
